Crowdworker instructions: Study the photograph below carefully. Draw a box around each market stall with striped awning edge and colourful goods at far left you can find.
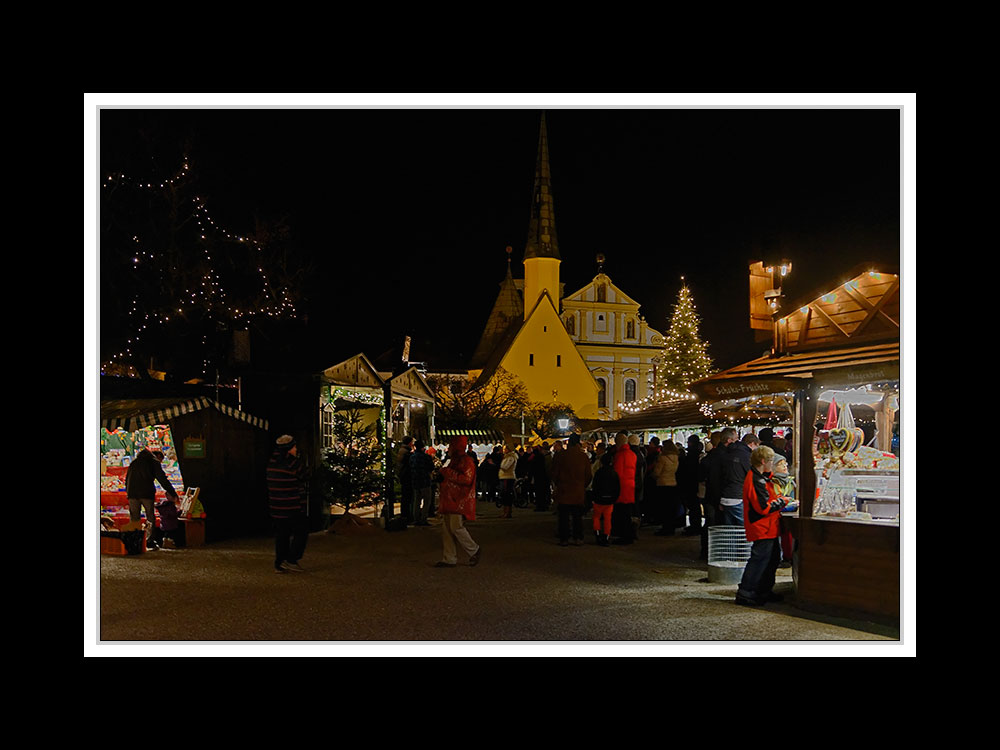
[100,397,268,551]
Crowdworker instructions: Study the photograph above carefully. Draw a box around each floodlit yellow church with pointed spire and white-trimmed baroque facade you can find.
[469,113,663,426]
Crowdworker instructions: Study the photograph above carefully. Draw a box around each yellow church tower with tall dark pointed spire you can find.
[524,112,562,318]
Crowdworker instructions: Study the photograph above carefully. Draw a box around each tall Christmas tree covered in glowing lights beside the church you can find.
[656,277,715,394]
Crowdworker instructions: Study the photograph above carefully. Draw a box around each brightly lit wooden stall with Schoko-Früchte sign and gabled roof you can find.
[691,270,905,622]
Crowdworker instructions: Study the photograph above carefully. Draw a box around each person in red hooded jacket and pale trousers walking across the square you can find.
[435,436,482,568]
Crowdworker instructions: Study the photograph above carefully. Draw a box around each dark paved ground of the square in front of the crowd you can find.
[92,503,902,654]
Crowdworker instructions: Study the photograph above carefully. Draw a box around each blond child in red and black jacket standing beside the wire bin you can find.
[736,445,785,607]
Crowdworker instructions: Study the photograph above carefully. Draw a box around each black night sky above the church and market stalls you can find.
[99,101,901,376]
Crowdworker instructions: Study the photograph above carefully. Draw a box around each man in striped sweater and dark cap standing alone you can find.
[267,435,309,573]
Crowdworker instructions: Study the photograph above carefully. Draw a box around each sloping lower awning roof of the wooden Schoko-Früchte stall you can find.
[690,341,899,400]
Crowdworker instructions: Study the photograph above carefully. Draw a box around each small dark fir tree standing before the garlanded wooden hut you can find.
[320,407,385,517]
